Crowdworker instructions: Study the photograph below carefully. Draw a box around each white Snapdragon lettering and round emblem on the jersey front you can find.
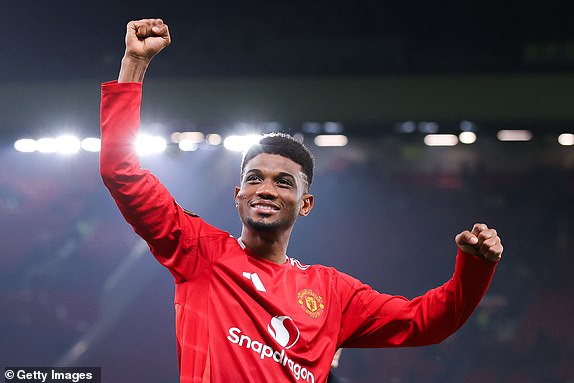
[227,317,315,383]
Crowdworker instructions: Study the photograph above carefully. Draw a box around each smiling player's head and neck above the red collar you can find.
[235,144,314,263]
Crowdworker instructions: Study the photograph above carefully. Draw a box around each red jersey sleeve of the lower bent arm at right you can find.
[335,250,496,347]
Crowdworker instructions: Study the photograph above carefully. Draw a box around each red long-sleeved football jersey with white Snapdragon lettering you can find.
[101,82,495,383]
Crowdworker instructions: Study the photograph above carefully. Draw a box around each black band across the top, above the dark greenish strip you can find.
[6,0,574,81]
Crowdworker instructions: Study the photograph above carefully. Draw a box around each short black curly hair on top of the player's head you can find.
[241,132,315,189]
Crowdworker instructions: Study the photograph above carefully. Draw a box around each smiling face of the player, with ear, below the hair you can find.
[235,153,313,231]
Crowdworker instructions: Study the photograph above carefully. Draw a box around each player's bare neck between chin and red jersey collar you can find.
[239,227,290,264]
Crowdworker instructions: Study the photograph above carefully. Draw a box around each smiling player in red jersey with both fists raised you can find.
[101,19,502,382]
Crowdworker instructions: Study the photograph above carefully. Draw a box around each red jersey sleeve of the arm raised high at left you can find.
[100,81,214,281]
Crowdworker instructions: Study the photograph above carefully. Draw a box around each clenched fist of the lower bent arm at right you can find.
[455,223,503,262]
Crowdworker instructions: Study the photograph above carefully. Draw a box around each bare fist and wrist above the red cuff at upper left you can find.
[118,19,171,82]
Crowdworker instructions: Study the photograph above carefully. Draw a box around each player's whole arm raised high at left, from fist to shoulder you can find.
[100,19,214,280]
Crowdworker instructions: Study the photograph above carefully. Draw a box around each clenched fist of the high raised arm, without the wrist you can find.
[124,19,171,62]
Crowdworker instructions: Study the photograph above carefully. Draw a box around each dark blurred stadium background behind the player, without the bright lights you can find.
[0,0,574,383]
